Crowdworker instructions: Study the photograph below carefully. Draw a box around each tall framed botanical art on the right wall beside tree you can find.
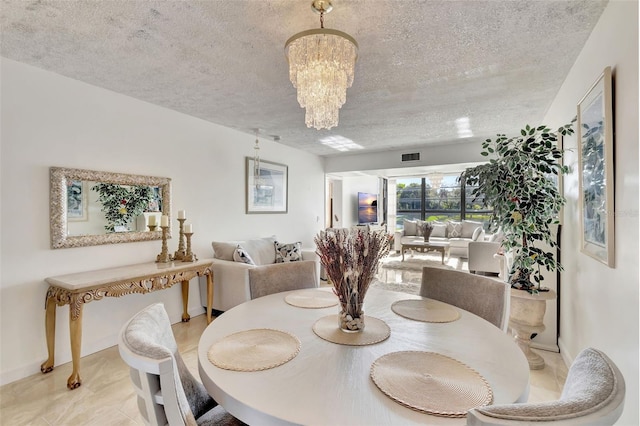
[577,67,614,267]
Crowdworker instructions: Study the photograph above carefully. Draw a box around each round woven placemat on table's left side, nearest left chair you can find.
[207,328,300,371]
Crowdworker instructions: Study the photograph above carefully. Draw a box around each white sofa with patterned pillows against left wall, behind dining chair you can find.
[200,236,320,312]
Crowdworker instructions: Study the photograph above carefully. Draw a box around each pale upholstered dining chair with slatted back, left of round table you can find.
[118,303,243,426]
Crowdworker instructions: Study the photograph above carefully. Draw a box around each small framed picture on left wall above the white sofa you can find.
[246,157,289,214]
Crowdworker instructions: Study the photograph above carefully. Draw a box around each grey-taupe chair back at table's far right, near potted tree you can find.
[420,266,509,331]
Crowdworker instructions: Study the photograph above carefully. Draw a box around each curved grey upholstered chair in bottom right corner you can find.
[467,348,625,426]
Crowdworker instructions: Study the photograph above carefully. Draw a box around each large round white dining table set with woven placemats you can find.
[198,288,529,426]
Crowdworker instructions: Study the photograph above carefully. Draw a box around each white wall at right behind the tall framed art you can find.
[545,0,640,425]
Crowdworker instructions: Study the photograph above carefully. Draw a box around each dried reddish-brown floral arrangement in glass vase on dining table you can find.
[315,229,391,332]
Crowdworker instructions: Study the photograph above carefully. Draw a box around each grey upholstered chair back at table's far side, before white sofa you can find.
[249,260,318,299]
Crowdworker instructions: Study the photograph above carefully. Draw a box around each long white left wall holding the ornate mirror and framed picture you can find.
[0,58,324,384]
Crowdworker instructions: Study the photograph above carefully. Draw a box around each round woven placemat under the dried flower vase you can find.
[313,315,391,346]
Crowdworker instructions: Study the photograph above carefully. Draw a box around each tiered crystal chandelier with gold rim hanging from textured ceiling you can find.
[284,0,358,130]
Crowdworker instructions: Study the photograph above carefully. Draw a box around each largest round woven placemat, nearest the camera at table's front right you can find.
[371,351,493,417]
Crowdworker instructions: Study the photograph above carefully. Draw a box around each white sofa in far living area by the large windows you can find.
[393,219,484,258]
